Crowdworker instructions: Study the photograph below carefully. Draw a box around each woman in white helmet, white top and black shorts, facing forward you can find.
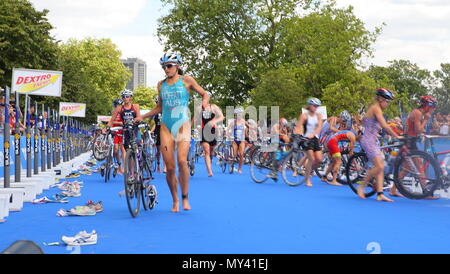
[294,98,323,187]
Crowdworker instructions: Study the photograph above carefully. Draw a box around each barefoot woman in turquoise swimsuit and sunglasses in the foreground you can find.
[139,53,209,212]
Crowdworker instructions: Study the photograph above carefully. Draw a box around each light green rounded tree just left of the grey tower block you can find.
[36,38,130,122]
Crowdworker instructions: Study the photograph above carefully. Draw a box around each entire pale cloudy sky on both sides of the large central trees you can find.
[31,0,450,86]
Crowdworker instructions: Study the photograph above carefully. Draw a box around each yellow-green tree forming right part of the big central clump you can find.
[275,2,381,98]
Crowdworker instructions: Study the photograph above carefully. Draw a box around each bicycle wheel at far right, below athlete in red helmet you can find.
[394,150,442,199]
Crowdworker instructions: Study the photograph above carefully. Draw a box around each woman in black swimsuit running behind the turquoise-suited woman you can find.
[197,101,224,177]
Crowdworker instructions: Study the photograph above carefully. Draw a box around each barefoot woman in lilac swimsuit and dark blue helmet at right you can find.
[358,88,398,202]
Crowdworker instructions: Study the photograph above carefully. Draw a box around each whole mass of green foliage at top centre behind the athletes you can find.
[158,0,380,112]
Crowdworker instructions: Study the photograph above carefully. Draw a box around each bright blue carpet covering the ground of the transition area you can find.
[0,140,450,254]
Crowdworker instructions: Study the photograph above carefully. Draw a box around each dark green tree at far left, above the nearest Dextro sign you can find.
[0,0,57,86]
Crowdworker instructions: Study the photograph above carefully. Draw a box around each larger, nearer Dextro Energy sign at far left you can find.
[12,68,62,97]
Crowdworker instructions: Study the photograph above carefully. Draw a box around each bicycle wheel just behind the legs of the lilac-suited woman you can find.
[345,152,376,197]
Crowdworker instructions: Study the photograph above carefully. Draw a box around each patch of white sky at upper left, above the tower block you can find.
[30,0,163,86]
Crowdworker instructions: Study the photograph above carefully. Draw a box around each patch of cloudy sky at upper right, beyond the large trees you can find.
[337,0,450,70]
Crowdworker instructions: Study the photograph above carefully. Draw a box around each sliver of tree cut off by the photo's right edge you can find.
[433,63,450,114]
